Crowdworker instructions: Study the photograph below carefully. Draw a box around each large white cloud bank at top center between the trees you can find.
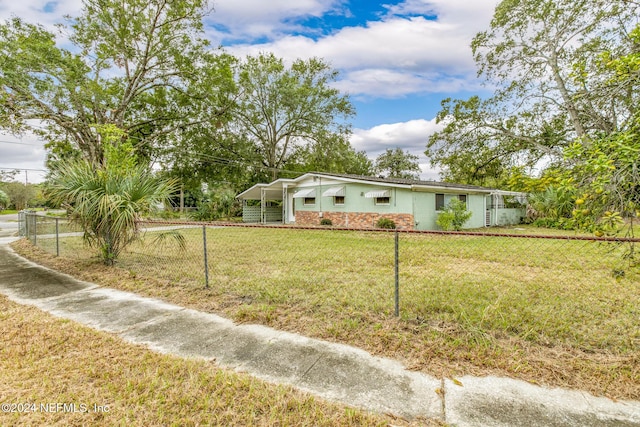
[221,0,497,97]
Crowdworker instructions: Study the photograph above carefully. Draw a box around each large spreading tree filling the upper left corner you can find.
[0,0,232,167]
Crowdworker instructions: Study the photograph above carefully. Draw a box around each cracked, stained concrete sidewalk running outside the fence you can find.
[0,242,640,427]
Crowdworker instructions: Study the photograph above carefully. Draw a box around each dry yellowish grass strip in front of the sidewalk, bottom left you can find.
[0,296,424,426]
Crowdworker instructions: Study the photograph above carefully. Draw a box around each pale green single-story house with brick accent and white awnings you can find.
[237,172,526,230]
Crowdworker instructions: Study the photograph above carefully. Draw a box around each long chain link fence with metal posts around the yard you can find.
[20,213,640,348]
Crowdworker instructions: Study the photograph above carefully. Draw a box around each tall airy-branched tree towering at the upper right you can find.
[426,0,640,184]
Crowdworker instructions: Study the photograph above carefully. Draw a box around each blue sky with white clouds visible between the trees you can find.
[0,0,498,180]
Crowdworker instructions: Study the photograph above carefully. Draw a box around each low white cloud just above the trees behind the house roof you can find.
[351,119,441,180]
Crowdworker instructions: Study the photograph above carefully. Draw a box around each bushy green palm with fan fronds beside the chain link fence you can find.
[46,161,177,265]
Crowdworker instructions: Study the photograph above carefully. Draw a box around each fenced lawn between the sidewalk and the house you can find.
[16,228,640,399]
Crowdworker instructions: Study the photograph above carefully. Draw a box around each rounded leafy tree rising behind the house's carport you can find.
[233,54,361,179]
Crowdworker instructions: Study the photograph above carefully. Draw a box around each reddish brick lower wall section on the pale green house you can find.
[296,211,414,230]
